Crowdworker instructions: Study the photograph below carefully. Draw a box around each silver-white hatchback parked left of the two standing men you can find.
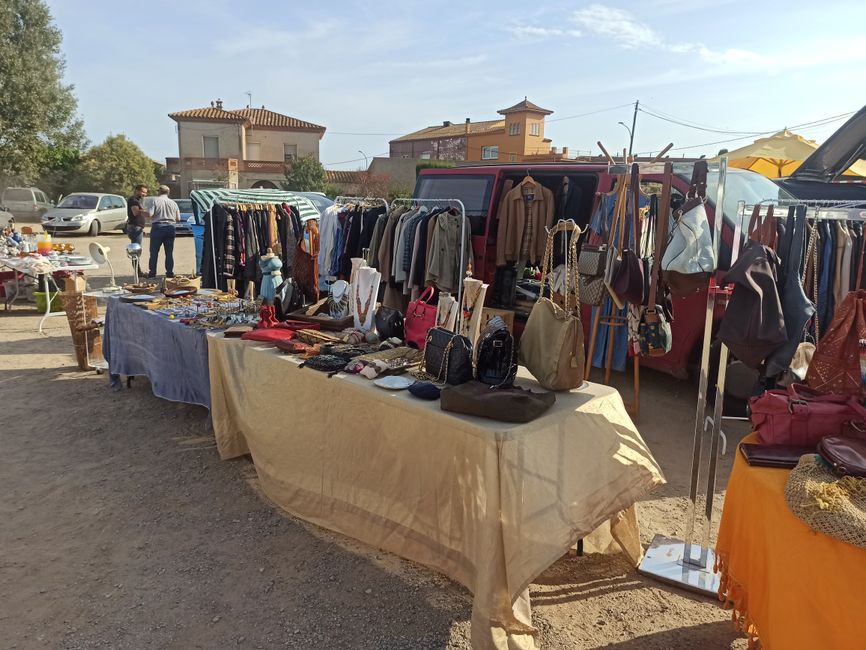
[42,192,126,237]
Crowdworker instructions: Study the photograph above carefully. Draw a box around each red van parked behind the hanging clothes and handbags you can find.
[414,163,793,378]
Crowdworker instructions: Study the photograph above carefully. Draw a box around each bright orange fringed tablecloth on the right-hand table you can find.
[716,434,866,650]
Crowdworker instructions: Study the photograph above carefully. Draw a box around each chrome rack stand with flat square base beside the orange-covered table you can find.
[638,156,730,596]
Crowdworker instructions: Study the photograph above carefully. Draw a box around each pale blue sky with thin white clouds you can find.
[48,0,866,169]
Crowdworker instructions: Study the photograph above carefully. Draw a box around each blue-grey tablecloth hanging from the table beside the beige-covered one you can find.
[103,298,210,408]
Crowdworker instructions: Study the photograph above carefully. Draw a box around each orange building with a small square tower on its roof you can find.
[390,97,567,162]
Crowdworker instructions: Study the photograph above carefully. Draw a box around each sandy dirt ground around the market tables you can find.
[0,236,745,650]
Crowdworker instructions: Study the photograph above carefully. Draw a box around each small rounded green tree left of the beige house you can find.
[77,134,156,196]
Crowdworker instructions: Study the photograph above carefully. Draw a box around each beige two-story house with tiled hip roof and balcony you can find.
[165,99,325,197]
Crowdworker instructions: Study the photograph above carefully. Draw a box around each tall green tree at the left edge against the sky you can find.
[0,0,86,181]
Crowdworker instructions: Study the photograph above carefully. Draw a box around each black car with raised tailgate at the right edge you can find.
[775,106,866,207]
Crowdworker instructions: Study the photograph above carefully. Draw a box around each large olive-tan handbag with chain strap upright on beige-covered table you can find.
[518,221,584,390]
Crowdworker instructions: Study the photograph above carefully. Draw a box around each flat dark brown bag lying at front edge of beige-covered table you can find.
[439,381,556,422]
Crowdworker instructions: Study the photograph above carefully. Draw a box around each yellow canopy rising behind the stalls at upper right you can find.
[711,129,866,178]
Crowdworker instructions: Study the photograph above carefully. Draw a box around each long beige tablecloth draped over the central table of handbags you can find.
[208,336,664,650]
